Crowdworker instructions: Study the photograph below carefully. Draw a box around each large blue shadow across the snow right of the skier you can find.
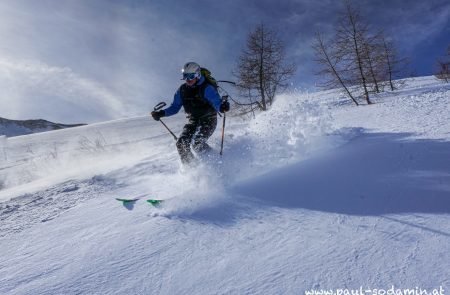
[232,133,450,216]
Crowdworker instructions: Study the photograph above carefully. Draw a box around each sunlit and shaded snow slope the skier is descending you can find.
[0,77,450,294]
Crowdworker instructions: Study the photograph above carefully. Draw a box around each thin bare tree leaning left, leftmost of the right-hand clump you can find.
[313,33,359,105]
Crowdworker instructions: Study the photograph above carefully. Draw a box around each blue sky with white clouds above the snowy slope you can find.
[0,0,450,123]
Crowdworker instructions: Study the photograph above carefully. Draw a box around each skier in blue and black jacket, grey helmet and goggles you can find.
[151,62,230,164]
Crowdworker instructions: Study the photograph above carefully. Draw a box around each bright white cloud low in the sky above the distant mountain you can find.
[0,58,125,123]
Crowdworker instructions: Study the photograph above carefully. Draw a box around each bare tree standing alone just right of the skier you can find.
[234,24,296,111]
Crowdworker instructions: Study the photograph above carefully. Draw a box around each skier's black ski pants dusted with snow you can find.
[177,114,217,164]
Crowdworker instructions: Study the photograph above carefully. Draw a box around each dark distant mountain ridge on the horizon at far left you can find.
[0,118,86,137]
